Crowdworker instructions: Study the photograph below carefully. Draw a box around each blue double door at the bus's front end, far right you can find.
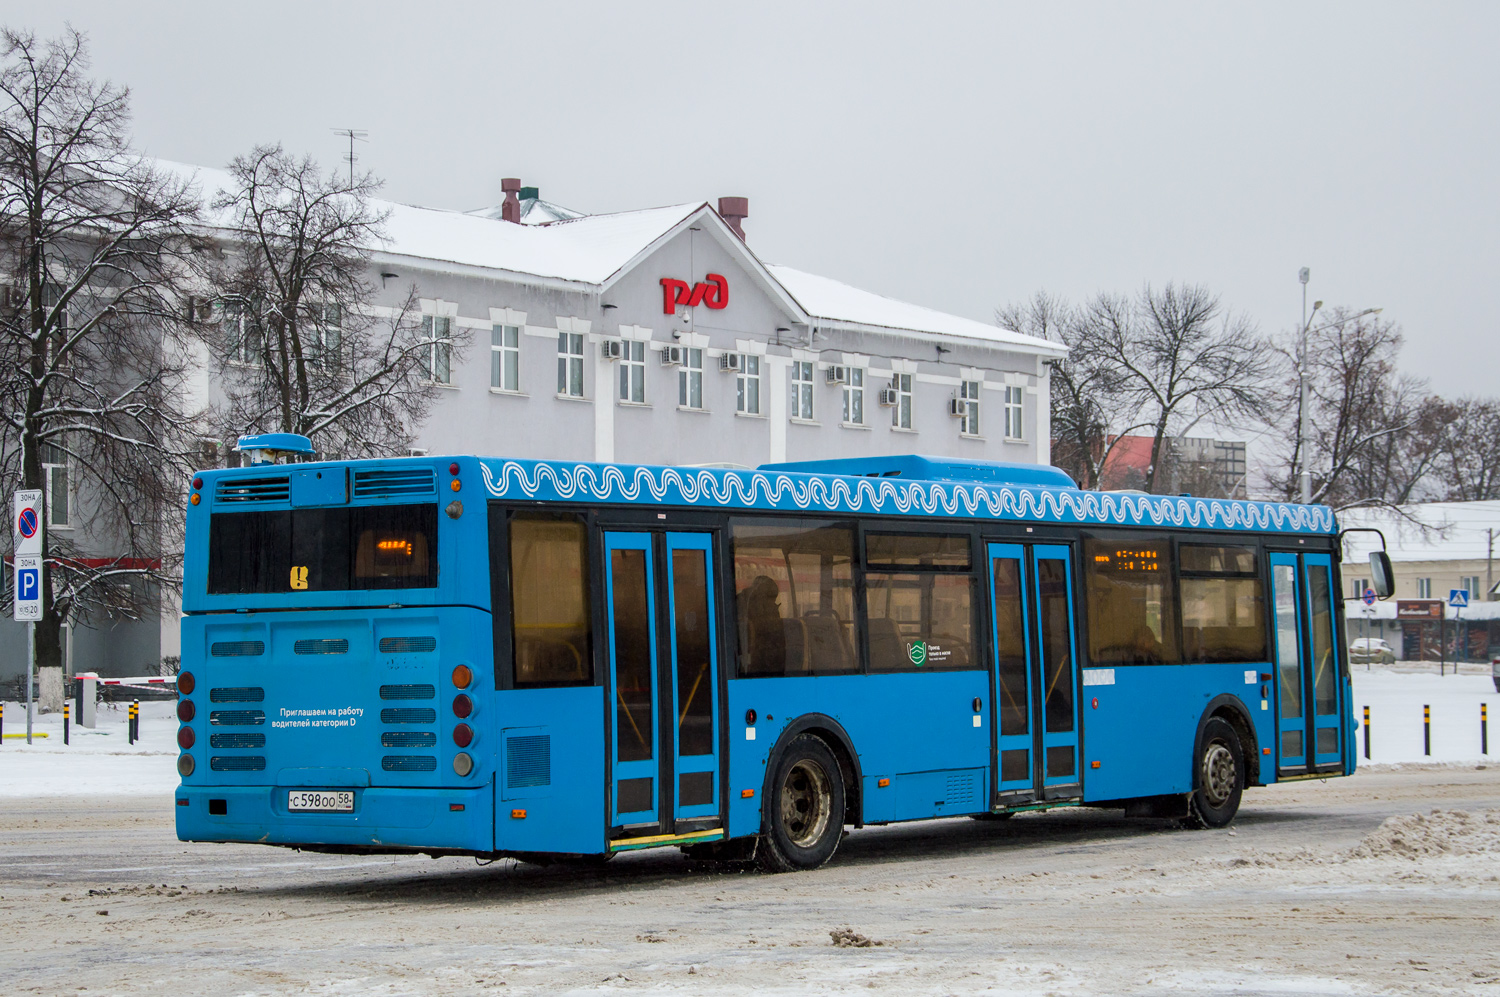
[1271,553,1346,775]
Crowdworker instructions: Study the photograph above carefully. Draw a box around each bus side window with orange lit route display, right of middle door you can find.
[1083,537,1181,666]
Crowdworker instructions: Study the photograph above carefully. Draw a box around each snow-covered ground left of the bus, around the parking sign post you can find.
[0,700,179,796]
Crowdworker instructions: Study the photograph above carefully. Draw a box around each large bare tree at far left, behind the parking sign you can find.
[0,28,197,677]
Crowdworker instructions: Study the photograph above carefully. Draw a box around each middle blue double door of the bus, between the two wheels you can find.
[989,544,1083,807]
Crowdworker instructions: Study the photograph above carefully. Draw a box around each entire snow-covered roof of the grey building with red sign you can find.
[158,160,1067,349]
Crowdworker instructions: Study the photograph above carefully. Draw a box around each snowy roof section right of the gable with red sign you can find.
[767,264,1068,357]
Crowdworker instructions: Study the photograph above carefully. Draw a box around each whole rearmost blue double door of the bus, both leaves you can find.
[605,532,720,837]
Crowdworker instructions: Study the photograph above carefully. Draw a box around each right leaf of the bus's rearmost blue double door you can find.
[663,534,719,831]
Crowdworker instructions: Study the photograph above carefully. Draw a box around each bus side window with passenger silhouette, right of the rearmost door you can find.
[731,523,860,676]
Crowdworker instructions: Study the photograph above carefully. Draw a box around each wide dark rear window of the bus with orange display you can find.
[209,504,438,595]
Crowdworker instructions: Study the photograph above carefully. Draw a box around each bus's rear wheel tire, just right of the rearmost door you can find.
[756,735,845,873]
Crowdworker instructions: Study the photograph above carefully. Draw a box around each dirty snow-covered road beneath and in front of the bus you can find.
[0,765,1500,996]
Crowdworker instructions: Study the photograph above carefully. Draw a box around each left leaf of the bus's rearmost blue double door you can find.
[605,532,662,826]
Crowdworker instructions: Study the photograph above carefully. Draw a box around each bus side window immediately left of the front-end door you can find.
[1178,544,1269,664]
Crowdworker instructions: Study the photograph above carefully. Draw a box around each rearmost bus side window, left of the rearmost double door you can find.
[510,516,594,687]
